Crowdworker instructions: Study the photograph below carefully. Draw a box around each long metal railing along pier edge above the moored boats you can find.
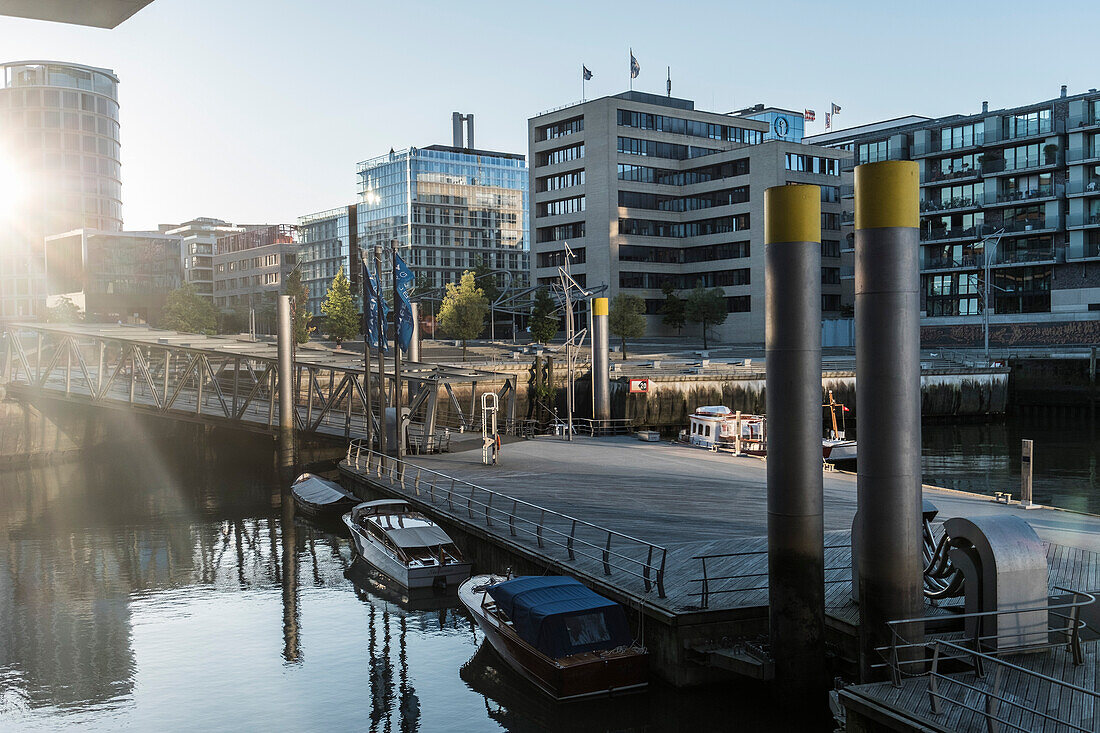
[348,439,668,598]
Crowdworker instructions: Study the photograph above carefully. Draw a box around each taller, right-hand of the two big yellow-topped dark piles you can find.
[853,161,924,679]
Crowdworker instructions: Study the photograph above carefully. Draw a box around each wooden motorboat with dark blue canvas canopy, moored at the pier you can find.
[459,576,649,701]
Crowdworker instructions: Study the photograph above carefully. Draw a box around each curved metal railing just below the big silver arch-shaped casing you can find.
[871,586,1096,687]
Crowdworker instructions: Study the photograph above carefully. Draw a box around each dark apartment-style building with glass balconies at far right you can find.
[809,87,1100,346]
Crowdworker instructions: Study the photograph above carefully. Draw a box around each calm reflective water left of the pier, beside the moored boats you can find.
[0,441,831,733]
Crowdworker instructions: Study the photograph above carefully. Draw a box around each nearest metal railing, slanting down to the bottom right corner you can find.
[926,641,1100,732]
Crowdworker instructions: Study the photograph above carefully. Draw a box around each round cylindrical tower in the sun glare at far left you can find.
[0,61,122,319]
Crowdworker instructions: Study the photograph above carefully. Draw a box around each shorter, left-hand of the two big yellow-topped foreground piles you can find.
[763,181,825,689]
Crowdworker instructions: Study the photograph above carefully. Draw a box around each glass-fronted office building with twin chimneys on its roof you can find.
[358,113,529,288]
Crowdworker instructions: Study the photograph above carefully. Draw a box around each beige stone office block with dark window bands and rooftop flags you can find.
[528,91,848,343]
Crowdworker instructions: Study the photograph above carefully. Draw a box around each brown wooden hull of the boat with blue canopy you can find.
[459,576,649,701]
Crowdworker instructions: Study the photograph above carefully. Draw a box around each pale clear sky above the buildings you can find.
[0,0,1100,230]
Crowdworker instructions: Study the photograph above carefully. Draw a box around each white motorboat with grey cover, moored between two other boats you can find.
[342,499,471,590]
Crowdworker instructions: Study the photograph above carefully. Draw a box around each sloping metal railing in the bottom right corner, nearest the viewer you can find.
[926,633,1100,732]
